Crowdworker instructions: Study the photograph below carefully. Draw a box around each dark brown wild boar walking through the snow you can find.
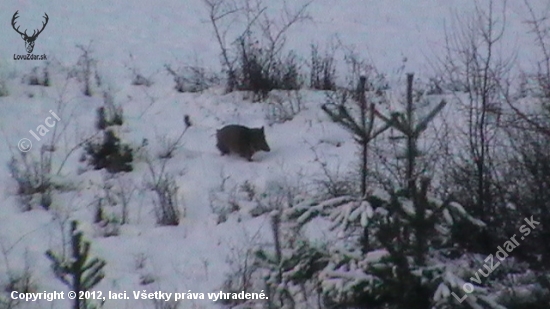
[216,124,271,161]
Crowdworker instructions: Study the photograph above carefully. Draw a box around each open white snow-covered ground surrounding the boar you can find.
[0,0,544,308]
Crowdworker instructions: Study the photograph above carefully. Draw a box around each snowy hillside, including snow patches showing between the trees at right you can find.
[0,0,545,309]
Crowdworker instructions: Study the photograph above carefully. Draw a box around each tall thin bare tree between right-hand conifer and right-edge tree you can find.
[438,0,514,246]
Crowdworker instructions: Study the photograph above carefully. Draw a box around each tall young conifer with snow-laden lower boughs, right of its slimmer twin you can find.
[288,74,501,309]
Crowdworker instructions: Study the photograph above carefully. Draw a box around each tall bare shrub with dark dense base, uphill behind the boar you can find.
[203,0,310,97]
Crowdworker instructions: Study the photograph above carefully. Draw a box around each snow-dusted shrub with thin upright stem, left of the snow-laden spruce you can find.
[225,180,321,308]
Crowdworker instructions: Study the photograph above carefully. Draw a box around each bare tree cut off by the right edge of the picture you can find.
[507,1,550,272]
